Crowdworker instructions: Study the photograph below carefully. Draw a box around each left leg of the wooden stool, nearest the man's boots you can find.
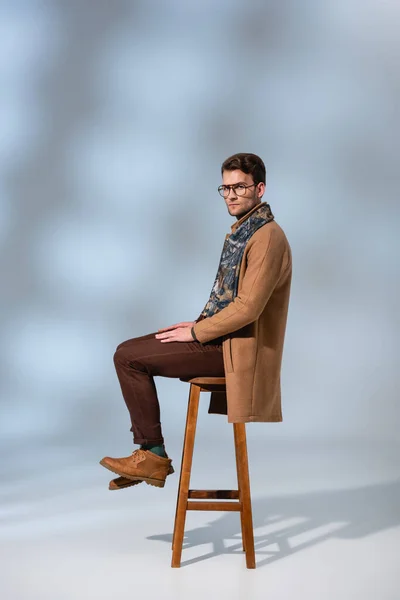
[171,383,200,568]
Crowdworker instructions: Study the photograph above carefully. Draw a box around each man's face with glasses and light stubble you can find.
[222,169,265,220]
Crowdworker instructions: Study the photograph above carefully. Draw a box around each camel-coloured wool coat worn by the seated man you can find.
[194,202,292,423]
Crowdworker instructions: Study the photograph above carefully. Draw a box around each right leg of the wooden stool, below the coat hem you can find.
[233,423,256,569]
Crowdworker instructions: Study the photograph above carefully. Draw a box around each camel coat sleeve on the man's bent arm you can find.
[193,230,288,343]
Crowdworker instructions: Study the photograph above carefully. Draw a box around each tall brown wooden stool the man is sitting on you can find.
[171,377,256,569]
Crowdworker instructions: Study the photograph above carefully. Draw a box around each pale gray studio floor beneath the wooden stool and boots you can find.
[0,437,400,600]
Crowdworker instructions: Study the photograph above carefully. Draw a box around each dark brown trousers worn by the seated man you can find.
[114,332,225,445]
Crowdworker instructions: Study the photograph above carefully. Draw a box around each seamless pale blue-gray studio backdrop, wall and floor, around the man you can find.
[0,0,400,600]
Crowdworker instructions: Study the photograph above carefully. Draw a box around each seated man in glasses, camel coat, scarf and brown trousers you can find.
[100,153,292,490]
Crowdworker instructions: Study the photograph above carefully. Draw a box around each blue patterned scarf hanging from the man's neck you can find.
[198,203,274,321]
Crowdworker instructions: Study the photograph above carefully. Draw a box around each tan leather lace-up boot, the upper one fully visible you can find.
[100,448,172,487]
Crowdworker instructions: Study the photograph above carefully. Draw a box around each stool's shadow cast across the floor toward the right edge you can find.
[147,479,400,568]
